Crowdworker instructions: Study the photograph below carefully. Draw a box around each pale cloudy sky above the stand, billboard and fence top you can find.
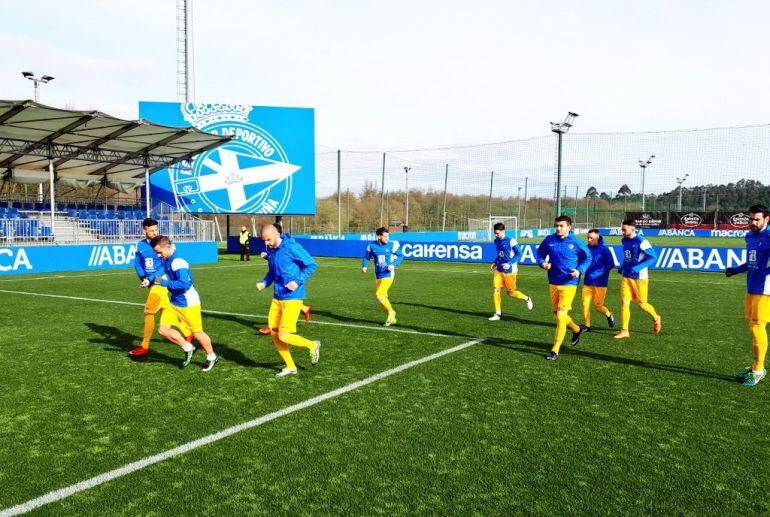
[0,0,770,149]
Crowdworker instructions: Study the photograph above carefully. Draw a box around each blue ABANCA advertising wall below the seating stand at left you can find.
[0,241,218,276]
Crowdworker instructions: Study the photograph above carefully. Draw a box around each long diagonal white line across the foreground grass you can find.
[0,339,483,517]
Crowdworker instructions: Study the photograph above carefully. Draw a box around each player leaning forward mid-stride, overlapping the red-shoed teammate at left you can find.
[144,235,219,372]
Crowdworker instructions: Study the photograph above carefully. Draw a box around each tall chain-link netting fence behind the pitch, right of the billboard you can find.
[287,125,770,233]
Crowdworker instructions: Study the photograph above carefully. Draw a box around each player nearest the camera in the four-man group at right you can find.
[537,215,591,361]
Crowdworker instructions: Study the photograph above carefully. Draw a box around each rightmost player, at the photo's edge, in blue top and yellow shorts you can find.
[725,205,770,386]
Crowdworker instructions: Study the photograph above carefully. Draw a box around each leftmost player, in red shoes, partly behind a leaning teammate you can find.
[128,217,192,357]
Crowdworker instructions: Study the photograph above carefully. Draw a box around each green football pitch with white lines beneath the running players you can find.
[0,255,770,515]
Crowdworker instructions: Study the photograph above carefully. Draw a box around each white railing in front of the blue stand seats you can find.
[0,216,214,246]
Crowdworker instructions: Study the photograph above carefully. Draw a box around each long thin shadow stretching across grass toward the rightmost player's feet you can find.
[481,338,735,383]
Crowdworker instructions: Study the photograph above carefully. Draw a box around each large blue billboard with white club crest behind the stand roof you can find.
[139,102,315,215]
